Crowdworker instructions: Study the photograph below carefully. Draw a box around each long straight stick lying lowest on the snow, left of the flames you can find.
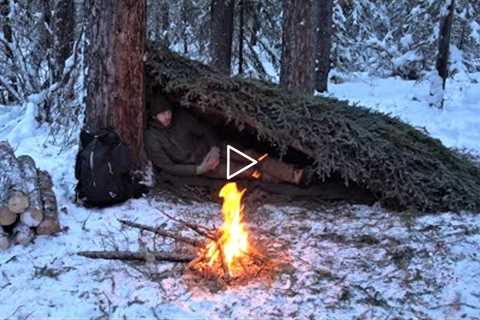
[77,251,195,262]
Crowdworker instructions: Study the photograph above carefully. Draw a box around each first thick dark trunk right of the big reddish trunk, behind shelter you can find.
[210,0,235,75]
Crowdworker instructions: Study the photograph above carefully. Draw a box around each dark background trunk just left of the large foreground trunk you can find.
[53,0,75,81]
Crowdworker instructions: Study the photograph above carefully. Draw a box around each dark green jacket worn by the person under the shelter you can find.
[145,109,220,176]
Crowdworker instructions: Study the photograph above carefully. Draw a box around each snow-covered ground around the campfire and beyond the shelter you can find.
[0,75,480,319]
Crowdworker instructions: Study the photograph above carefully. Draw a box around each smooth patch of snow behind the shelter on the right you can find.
[327,73,480,154]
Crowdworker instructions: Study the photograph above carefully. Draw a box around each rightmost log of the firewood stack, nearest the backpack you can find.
[36,170,60,234]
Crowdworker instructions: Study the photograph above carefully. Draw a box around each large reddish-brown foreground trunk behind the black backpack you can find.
[85,0,146,169]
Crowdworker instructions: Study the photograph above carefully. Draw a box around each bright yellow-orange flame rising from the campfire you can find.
[206,182,249,276]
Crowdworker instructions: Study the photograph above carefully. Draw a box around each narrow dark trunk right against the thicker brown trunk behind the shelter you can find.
[313,0,333,92]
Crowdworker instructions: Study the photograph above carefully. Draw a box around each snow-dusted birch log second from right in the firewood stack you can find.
[18,156,43,227]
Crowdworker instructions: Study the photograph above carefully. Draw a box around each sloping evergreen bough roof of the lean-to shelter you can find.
[146,43,480,211]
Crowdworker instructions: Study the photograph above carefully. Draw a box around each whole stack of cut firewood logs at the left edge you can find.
[0,141,60,251]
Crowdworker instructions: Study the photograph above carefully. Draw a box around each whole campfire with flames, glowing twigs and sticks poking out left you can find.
[79,182,288,285]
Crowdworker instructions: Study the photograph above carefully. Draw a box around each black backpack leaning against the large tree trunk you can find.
[75,129,146,207]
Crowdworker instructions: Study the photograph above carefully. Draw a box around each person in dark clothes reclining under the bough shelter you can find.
[145,95,310,185]
